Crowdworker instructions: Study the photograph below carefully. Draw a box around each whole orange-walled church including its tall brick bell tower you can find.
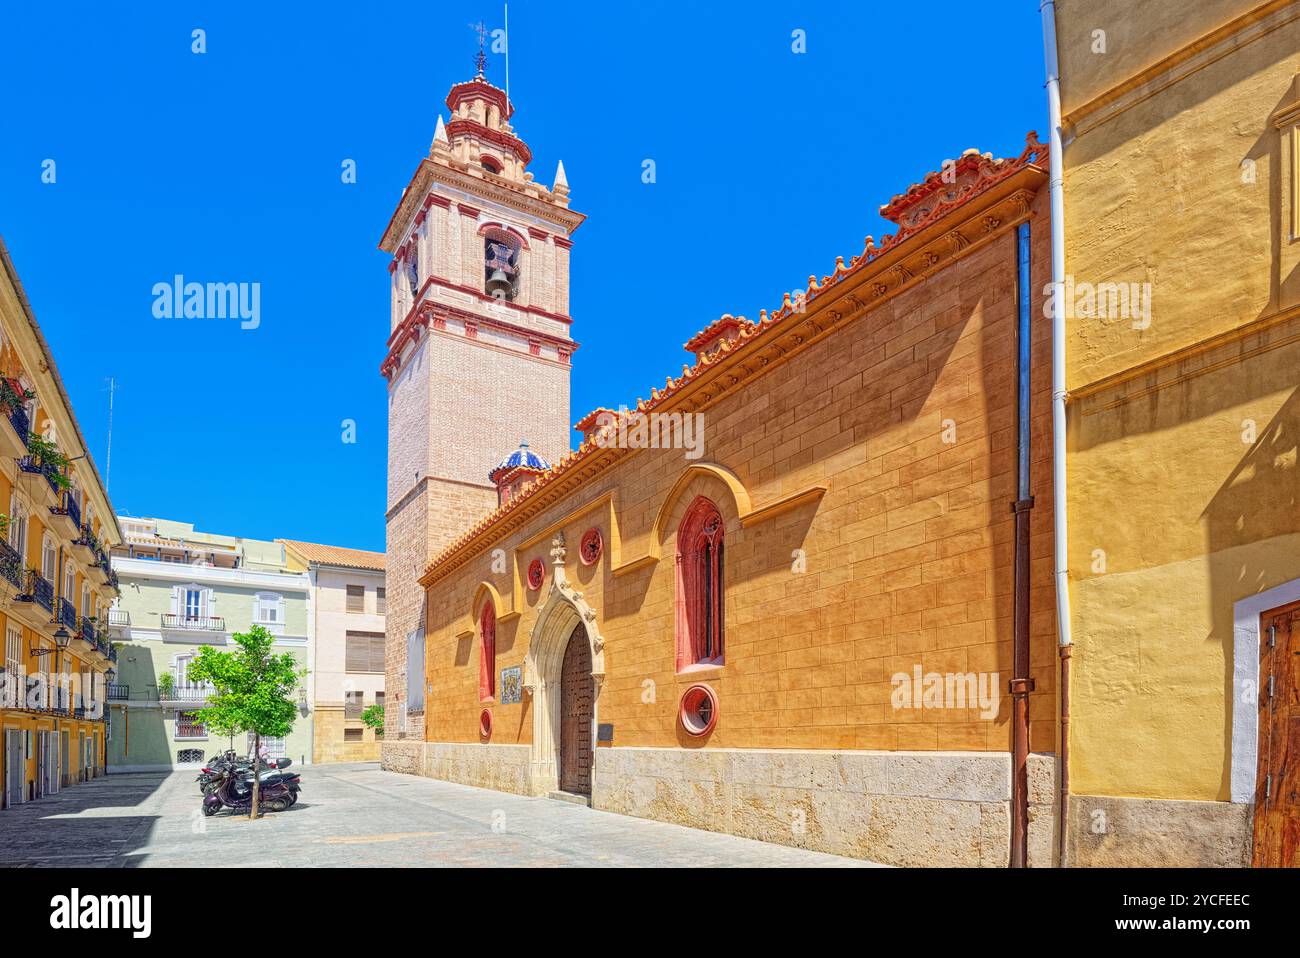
[381,63,1060,867]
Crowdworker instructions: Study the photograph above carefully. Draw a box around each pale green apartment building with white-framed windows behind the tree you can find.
[109,516,312,771]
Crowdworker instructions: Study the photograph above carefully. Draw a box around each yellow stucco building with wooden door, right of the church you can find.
[1056,0,1300,864]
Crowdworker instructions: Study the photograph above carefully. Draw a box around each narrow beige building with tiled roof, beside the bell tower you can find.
[282,539,387,762]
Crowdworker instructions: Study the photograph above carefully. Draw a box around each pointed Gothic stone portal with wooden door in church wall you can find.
[524,533,605,796]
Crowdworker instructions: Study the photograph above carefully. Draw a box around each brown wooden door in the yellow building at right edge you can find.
[1255,602,1300,868]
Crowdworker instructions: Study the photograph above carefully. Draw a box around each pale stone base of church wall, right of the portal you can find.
[593,747,1056,868]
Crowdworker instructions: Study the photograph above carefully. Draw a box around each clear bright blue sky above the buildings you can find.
[0,0,1047,550]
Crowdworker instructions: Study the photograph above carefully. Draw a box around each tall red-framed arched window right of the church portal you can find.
[676,495,725,672]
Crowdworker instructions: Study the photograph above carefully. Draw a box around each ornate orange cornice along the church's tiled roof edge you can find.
[420,131,1048,588]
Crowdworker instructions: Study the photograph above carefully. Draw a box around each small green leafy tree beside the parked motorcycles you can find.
[187,625,307,818]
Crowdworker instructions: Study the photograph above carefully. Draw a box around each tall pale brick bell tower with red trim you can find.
[380,57,585,753]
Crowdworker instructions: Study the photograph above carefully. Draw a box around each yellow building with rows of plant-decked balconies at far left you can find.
[0,237,121,809]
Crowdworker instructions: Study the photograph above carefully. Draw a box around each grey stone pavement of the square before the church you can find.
[0,764,870,868]
